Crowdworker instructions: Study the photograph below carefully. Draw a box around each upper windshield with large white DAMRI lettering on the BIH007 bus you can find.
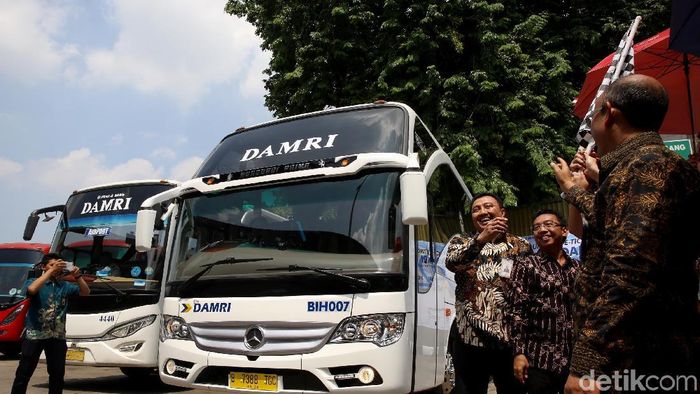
[195,106,408,177]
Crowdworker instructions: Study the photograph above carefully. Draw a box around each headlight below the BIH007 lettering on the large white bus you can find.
[329,313,406,346]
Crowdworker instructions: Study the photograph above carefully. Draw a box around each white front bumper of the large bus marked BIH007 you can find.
[158,332,413,393]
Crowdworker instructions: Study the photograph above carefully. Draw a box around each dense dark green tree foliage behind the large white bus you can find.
[226,0,670,205]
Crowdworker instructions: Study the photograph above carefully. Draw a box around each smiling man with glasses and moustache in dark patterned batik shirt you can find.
[508,209,579,394]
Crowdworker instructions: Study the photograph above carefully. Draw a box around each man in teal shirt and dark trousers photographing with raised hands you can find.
[12,253,90,394]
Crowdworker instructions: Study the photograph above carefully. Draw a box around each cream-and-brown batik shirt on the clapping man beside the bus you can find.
[445,234,532,347]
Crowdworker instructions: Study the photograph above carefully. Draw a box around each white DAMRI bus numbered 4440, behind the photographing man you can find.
[24,180,176,377]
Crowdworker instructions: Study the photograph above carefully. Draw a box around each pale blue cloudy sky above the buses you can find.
[0,0,273,242]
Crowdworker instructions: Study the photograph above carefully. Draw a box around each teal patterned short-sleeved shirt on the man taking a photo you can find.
[24,279,80,339]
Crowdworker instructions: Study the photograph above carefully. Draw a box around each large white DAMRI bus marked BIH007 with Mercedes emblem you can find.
[136,102,470,393]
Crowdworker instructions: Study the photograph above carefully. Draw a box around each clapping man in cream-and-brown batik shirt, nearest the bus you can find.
[445,193,532,394]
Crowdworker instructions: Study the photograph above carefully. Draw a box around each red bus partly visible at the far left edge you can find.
[0,243,51,356]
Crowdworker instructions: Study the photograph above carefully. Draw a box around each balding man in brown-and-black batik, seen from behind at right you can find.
[551,75,700,393]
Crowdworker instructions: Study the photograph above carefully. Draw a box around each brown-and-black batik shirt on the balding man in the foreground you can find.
[564,133,700,376]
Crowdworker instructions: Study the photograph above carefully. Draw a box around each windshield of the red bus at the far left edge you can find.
[0,249,43,304]
